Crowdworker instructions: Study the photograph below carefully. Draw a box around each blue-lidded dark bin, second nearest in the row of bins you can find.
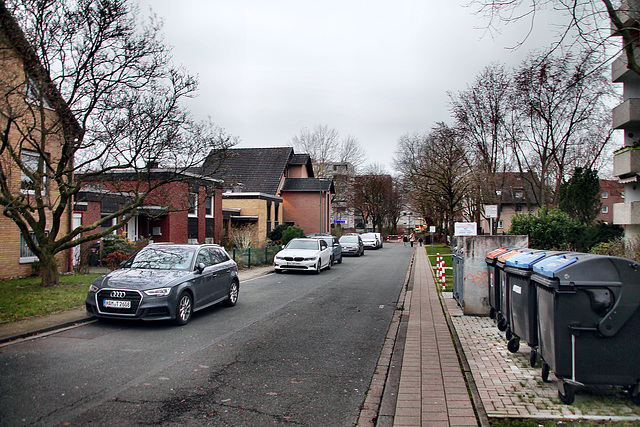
[504,250,558,366]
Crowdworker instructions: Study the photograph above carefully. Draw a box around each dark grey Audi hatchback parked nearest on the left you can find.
[85,244,240,325]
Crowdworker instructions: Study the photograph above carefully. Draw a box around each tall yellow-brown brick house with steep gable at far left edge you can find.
[0,3,80,278]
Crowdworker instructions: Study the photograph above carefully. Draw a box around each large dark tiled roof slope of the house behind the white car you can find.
[204,147,295,195]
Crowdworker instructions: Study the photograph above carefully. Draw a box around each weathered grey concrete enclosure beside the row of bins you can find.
[453,236,529,316]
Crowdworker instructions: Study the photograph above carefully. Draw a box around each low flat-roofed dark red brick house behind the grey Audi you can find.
[73,170,222,260]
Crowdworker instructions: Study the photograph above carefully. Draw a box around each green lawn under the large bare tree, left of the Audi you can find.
[0,273,100,322]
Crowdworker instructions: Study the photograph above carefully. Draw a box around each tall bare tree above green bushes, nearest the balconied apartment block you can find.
[510,52,613,206]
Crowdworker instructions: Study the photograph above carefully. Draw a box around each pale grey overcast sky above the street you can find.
[140,0,554,172]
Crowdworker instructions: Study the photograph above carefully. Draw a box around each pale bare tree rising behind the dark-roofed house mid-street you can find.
[291,125,366,178]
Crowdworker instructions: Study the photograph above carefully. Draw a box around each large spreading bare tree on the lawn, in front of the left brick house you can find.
[0,0,235,285]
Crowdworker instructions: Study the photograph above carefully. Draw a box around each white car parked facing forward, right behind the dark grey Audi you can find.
[273,238,331,274]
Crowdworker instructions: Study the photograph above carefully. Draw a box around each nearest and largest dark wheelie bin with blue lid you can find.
[531,253,640,404]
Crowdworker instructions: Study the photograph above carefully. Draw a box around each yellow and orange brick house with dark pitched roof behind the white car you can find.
[203,147,335,246]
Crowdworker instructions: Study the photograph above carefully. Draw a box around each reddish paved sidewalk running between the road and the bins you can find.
[393,248,478,427]
